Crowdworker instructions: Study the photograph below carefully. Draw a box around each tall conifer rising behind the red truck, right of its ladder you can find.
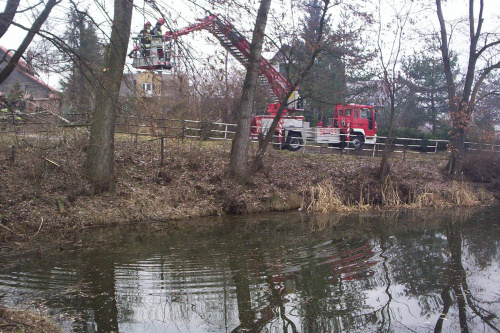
[297,0,373,120]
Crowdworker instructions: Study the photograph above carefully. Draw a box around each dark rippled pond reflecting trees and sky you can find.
[0,207,500,332]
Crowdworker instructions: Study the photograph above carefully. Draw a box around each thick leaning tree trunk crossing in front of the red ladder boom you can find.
[229,0,271,181]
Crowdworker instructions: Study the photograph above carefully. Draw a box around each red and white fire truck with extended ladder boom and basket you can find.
[132,14,377,151]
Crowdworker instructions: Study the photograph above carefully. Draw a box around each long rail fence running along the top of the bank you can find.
[0,115,500,156]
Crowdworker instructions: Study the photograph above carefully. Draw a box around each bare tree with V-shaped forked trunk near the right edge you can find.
[436,0,500,176]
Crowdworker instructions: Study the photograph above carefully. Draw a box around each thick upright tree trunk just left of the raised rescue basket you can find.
[86,0,133,193]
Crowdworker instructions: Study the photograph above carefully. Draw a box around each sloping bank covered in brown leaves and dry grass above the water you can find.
[0,135,494,247]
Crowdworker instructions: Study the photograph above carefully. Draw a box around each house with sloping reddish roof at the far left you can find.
[0,46,61,113]
